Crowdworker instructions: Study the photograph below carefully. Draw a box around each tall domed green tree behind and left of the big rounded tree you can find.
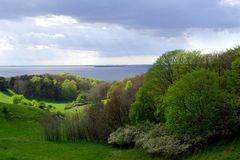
[130,50,200,122]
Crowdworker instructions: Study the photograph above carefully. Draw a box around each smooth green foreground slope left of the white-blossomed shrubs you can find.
[0,103,159,160]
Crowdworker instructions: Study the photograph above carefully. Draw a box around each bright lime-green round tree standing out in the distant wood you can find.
[61,79,77,99]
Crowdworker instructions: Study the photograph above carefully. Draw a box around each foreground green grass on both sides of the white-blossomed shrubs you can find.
[0,94,240,160]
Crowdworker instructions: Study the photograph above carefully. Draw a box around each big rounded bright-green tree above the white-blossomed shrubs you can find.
[163,69,224,134]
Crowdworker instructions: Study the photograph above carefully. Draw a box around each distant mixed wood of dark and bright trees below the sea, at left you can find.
[5,74,98,100]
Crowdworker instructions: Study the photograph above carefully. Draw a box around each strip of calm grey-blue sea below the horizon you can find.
[0,65,151,81]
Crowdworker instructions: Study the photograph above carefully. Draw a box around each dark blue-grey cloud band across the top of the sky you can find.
[0,0,240,29]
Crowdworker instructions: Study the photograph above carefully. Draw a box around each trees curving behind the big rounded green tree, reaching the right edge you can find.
[130,47,240,122]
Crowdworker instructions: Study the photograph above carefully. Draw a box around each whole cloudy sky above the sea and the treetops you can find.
[0,0,240,66]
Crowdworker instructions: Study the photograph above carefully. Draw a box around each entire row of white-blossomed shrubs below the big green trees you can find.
[108,124,192,157]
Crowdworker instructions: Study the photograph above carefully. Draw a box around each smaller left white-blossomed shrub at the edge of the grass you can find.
[108,125,140,147]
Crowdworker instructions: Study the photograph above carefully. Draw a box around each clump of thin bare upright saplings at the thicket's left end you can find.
[41,112,90,141]
